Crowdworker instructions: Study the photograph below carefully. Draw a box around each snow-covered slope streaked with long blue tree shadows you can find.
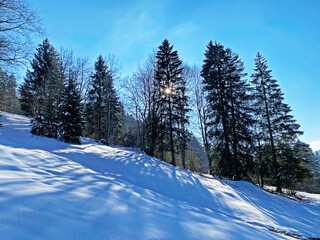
[0,113,320,240]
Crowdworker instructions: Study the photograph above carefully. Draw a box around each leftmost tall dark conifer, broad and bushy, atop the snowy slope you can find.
[20,39,64,138]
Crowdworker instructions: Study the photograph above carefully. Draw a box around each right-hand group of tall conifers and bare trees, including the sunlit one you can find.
[126,40,313,191]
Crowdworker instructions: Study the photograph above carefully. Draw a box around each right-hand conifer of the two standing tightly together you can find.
[225,49,254,180]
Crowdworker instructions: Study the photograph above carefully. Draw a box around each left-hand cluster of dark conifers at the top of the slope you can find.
[19,39,123,144]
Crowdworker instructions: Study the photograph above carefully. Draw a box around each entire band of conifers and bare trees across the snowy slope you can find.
[0,0,320,192]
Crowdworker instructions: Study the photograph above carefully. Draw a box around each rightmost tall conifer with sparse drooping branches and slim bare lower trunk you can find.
[251,53,302,192]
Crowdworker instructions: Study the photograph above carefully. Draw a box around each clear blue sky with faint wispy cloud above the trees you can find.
[30,0,320,150]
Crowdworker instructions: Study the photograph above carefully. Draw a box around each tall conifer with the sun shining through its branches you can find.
[155,39,186,166]
